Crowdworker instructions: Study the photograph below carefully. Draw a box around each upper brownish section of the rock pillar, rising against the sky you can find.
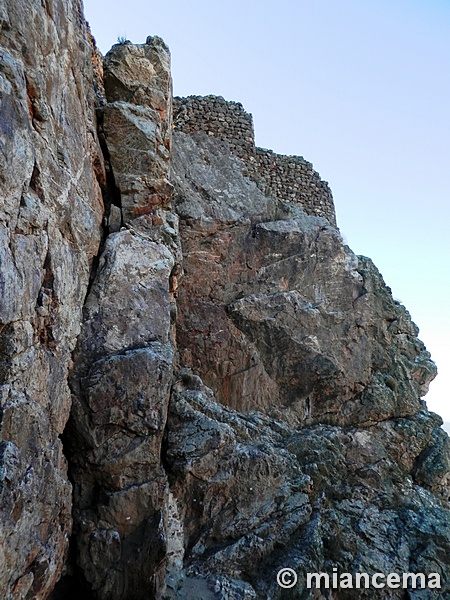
[103,37,172,222]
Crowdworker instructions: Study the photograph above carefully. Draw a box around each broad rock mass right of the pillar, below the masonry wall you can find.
[167,132,450,599]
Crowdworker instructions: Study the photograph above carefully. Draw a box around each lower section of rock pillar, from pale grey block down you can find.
[67,218,175,600]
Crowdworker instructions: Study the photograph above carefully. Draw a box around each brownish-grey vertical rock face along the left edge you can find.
[0,0,104,599]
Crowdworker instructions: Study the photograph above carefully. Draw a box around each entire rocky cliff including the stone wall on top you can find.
[0,0,450,600]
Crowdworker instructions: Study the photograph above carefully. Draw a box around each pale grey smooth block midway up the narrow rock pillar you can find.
[75,228,175,361]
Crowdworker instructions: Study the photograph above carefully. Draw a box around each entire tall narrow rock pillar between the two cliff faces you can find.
[66,38,181,600]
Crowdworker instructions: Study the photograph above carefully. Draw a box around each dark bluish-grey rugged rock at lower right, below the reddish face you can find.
[166,374,450,599]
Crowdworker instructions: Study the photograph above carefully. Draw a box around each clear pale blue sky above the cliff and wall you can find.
[84,0,450,421]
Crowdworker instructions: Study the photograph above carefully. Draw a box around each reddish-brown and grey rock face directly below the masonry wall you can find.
[173,133,435,425]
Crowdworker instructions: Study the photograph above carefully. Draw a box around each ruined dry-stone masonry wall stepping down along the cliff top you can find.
[173,95,336,226]
